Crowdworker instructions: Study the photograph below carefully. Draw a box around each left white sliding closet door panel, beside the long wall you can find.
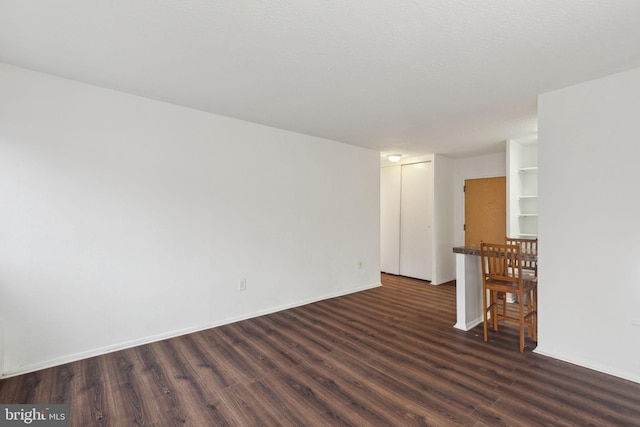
[380,166,401,274]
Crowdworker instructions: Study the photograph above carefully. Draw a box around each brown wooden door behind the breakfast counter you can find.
[464,176,507,246]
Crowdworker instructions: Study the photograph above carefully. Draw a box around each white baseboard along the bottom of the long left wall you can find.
[0,283,382,379]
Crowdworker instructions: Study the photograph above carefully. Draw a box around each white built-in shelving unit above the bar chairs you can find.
[507,136,538,238]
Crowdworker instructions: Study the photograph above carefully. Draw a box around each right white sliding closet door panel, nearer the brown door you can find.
[400,162,433,280]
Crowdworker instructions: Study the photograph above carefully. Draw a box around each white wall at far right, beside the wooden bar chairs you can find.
[537,69,640,382]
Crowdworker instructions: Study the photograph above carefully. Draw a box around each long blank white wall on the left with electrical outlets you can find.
[0,64,380,375]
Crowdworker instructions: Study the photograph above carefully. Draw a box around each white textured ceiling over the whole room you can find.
[0,0,640,160]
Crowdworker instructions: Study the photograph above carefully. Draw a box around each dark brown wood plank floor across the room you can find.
[0,275,640,427]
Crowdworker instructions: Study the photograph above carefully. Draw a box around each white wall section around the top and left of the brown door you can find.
[453,153,507,246]
